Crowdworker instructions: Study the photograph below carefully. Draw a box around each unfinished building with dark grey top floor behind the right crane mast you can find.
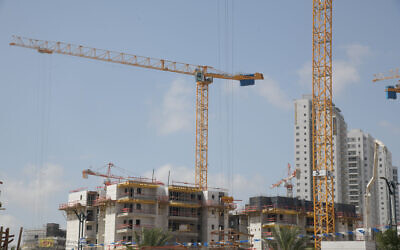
[229,196,360,249]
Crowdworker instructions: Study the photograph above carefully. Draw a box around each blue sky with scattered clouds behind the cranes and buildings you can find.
[0,0,400,232]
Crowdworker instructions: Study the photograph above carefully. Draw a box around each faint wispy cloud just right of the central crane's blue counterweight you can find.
[254,75,292,110]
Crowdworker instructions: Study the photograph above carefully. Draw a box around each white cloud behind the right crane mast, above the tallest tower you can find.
[297,44,371,95]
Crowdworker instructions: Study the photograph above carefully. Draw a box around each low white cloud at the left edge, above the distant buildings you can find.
[3,163,66,211]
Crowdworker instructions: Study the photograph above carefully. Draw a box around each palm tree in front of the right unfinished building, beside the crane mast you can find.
[268,226,307,250]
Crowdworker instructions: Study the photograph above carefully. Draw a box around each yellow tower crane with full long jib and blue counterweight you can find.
[10,36,264,190]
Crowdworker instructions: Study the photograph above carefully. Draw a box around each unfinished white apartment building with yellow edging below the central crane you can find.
[60,180,233,249]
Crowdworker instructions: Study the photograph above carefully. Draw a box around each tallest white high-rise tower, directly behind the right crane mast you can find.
[294,95,347,203]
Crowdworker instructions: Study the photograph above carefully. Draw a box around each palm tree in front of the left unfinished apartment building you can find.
[127,228,171,249]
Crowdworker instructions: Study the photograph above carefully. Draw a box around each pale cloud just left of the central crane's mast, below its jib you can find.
[152,79,195,135]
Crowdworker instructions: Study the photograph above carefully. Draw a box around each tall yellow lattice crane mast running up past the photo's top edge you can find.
[312,0,335,249]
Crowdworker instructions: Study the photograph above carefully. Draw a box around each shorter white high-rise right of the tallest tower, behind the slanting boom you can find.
[347,129,398,227]
